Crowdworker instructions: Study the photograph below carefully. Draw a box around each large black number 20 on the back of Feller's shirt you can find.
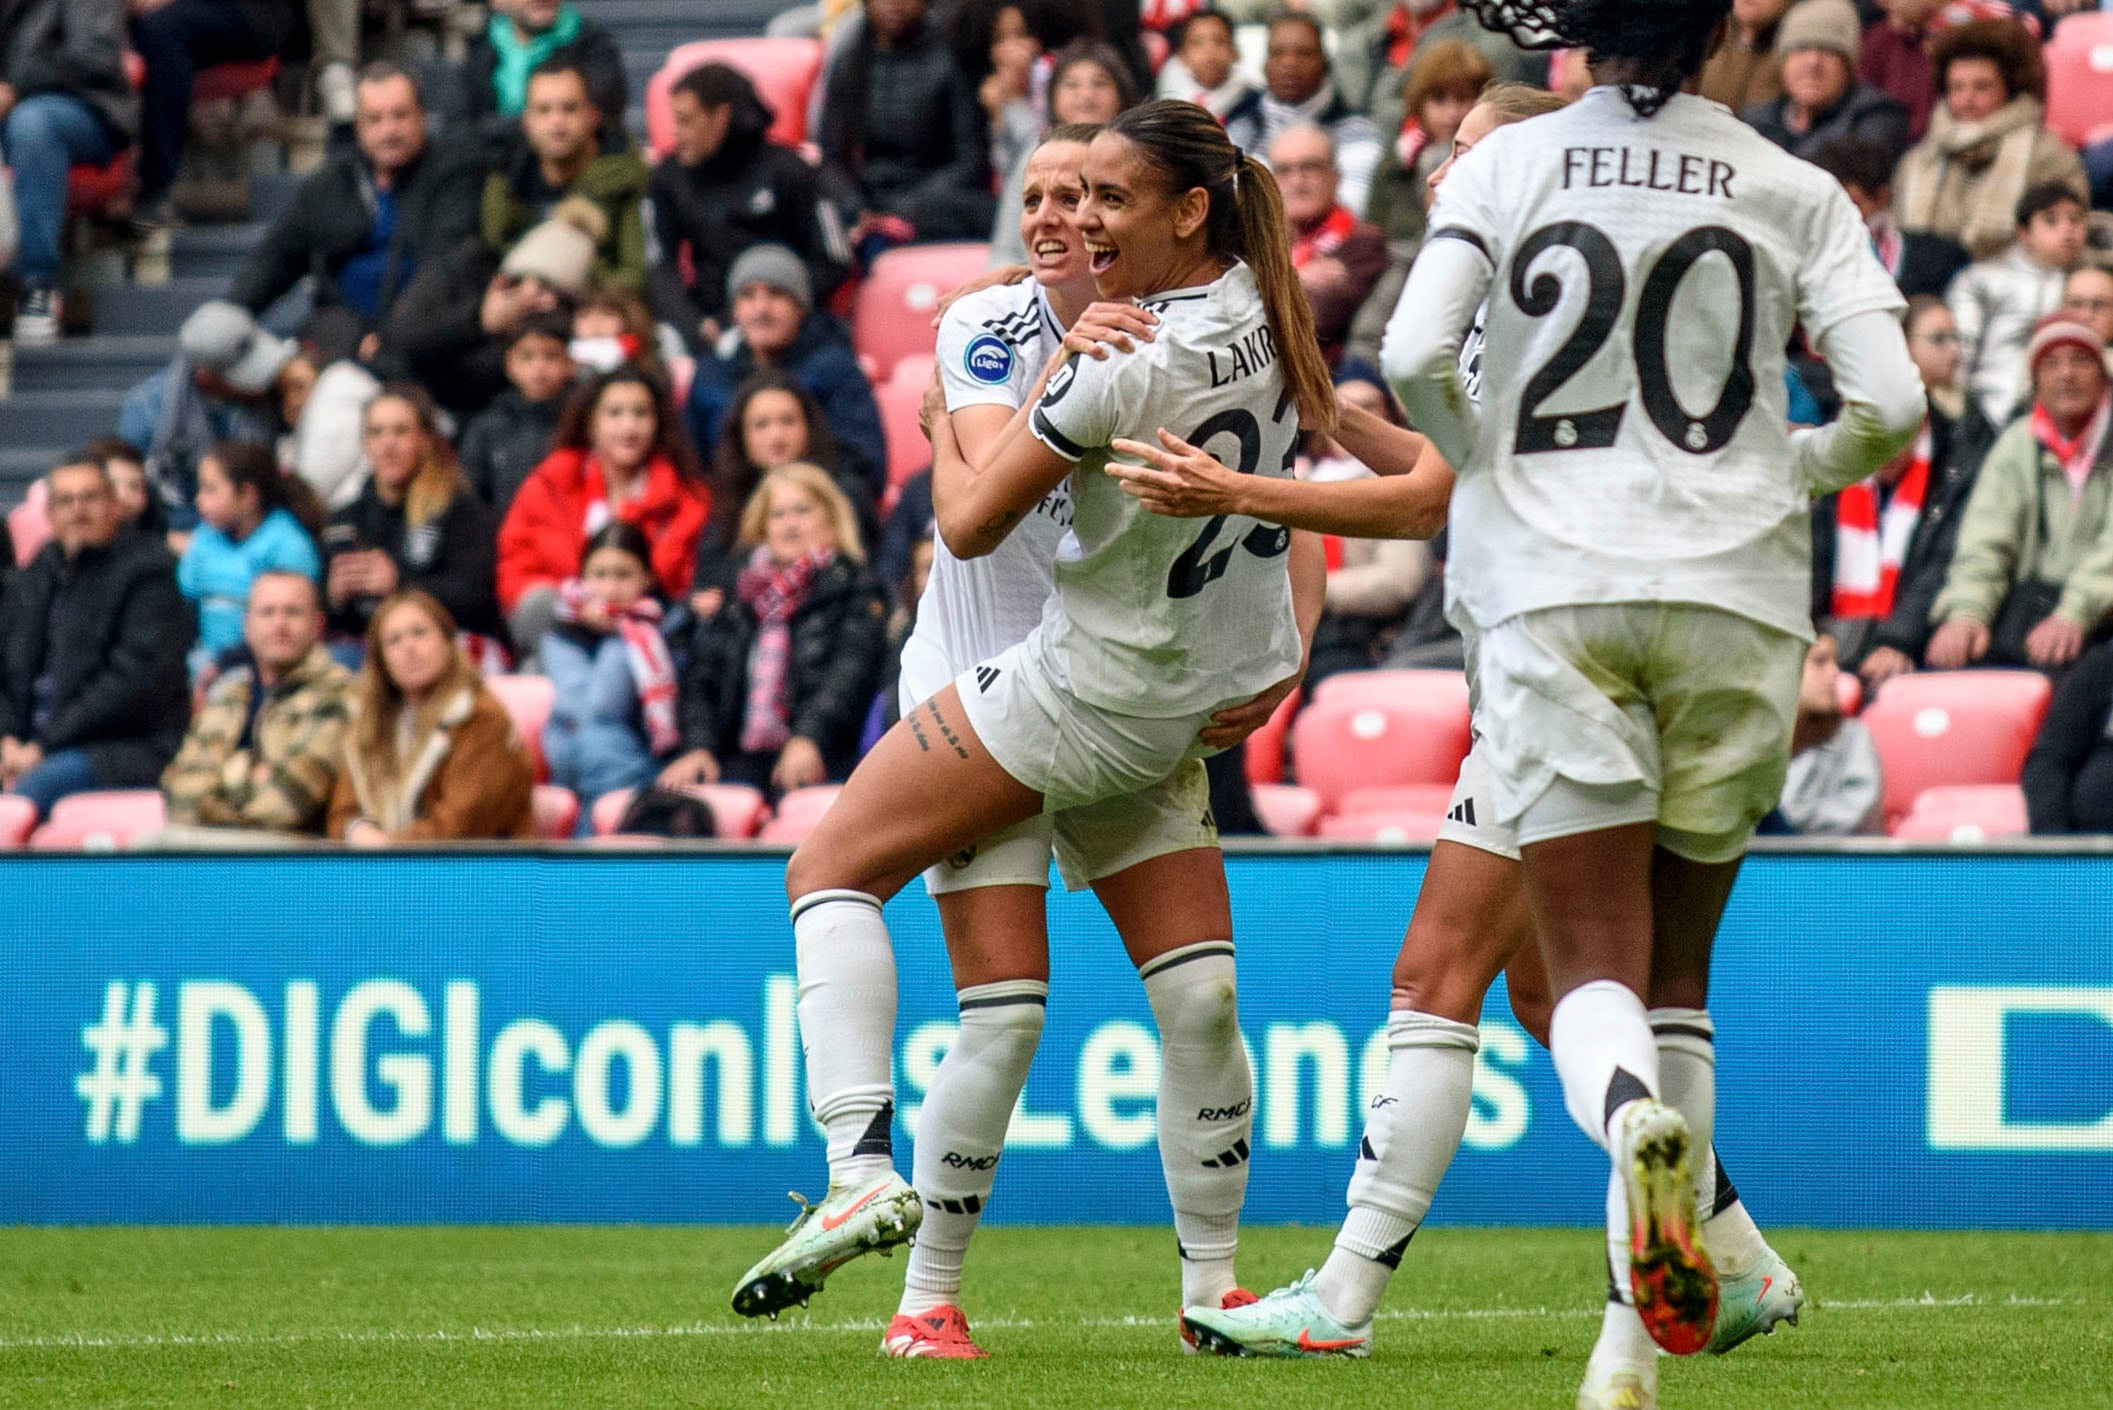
[1511,220,1754,454]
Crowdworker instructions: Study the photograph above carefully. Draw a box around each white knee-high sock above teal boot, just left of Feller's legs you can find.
[1314,1010,1481,1328]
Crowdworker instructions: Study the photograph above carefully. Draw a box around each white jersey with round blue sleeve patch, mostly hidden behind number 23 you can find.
[911,279,1071,680]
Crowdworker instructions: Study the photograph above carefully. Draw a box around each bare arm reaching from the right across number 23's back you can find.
[1107,424,1454,539]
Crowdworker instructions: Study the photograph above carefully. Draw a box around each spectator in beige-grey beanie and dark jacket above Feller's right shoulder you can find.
[1741,0,1908,159]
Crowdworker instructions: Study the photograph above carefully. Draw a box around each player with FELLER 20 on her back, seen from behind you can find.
[1384,0,1923,1406]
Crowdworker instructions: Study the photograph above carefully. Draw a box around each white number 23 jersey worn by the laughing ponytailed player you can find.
[1031,264,1299,719]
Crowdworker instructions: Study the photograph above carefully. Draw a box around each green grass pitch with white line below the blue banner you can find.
[0,1228,2113,1410]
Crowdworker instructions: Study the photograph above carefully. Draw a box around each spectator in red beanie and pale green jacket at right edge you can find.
[1925,313,2113,670]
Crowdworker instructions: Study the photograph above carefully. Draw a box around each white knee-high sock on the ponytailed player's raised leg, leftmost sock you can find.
[792,890,896,1186]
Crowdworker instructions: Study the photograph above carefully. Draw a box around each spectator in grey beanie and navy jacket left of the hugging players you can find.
[689,245,887,497]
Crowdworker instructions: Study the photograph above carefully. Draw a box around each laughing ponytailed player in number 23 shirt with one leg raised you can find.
[735,101,1335,1315]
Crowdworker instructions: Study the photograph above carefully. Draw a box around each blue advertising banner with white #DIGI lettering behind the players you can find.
[0,852,2113,1228]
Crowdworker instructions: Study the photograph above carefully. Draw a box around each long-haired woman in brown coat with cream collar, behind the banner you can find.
[330,590,535,848]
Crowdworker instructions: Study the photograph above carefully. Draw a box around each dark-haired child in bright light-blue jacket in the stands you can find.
[175,442,323,679]
